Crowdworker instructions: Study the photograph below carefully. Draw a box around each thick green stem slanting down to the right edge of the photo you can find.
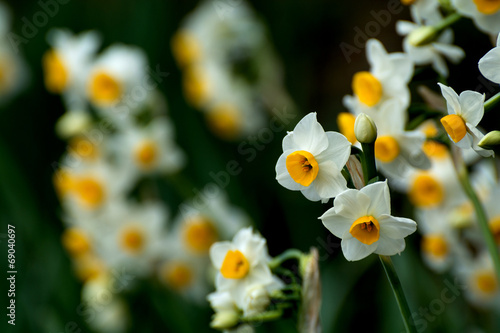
[457,161,500,282]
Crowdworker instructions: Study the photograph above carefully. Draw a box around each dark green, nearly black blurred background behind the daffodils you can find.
[0,0,500,333]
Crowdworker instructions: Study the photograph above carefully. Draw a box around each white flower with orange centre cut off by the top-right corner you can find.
[452,0,500,35]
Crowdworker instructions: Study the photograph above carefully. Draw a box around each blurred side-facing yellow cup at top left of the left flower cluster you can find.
[42,50,68,94]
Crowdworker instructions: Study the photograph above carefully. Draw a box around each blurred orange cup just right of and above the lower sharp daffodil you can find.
[408,173,444,207]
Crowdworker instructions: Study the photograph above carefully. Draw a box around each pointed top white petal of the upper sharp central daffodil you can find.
[293,112,328,155]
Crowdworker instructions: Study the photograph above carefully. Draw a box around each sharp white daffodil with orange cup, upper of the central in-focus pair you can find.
[276,113,351,202]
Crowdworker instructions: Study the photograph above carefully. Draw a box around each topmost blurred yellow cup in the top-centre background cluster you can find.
[183,66,211,107]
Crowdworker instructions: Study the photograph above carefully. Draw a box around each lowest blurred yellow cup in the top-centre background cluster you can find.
[206,104,242,139]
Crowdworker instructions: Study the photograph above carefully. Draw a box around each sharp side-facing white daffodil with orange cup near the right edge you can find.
[438,83,494,157]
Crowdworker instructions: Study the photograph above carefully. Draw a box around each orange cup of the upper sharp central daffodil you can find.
[286,150,319,186]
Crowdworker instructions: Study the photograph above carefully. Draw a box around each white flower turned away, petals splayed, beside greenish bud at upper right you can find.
[396,12,465,77]
